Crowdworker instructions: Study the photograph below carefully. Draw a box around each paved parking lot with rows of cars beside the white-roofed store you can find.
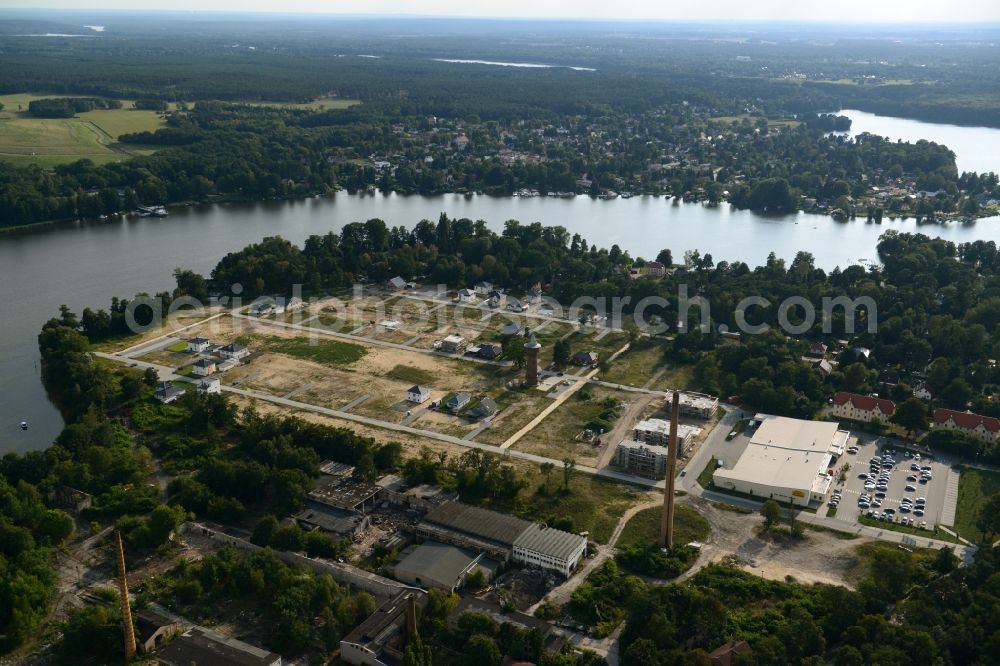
[820,438,949,529]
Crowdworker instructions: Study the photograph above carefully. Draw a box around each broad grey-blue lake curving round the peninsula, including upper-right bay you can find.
[0,111,1000,454]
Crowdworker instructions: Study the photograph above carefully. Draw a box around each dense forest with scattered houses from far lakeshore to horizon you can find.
[0,19,1000,226]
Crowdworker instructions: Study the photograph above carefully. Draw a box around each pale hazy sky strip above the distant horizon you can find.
[0,0,1000,22]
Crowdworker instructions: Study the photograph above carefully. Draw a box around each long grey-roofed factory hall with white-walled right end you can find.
[417,502,587,576]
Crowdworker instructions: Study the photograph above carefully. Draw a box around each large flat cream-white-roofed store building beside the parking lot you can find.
[712,415,850,506]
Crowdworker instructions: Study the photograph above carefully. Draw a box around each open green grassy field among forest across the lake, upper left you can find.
[0,93,165,167]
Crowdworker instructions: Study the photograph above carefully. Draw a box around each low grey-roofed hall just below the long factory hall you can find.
[393,541,499,593]
